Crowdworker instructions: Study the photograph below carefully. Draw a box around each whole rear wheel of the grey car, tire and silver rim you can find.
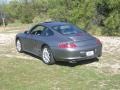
[42,46,55,65]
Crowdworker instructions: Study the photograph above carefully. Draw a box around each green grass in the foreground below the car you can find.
[0,57,120,90]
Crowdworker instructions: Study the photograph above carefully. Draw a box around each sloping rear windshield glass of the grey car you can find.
[52,24,82,34]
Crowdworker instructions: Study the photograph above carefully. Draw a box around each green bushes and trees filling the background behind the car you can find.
[1,0,120,36]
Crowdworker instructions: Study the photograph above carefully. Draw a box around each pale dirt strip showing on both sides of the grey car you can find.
[0,29,120,74]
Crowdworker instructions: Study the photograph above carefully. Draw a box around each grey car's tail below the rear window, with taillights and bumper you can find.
[53,35,102,62]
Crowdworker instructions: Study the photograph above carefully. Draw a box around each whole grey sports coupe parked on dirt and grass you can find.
[16,21,102,65]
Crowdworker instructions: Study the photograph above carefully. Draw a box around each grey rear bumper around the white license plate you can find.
[52,45,102,62]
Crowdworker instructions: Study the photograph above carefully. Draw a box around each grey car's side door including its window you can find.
[26,25,45,55]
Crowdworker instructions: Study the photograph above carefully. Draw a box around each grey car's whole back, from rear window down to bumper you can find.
[52,24,102,61]
